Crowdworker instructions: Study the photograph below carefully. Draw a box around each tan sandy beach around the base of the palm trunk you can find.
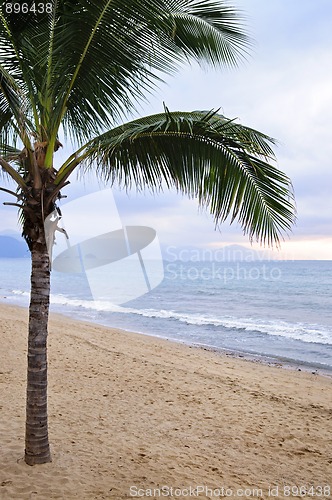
[0,305,332,500]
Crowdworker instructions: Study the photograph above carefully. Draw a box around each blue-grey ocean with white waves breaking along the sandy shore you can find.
[0,259,332,370]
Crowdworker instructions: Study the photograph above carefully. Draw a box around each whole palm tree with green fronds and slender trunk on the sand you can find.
[0,0,294,465]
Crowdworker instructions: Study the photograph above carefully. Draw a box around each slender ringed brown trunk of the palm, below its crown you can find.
[25,234,51,465]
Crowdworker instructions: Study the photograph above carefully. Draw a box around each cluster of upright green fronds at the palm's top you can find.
[0,0,249,146]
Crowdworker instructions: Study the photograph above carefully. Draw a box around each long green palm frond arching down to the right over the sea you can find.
[56,109,295,245]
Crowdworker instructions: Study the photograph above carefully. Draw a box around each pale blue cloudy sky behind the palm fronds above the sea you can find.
[0,0,332,260]
